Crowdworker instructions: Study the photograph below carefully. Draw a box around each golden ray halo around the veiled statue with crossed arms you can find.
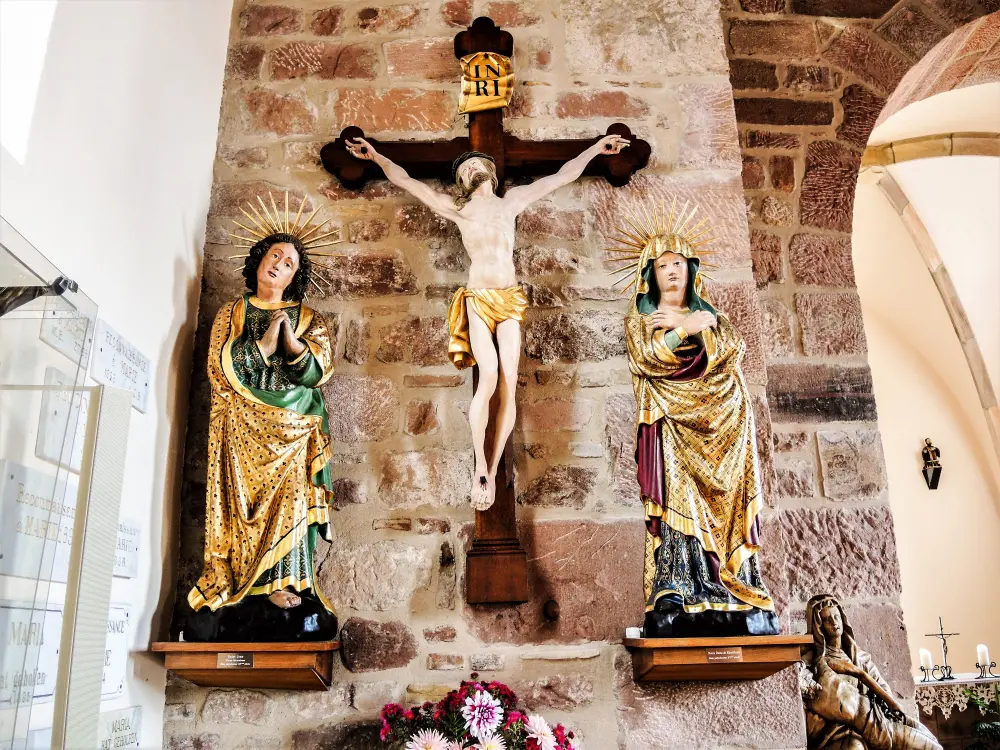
[604,198,718,295]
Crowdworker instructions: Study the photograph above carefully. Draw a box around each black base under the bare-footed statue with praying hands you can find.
[183,590,337,643]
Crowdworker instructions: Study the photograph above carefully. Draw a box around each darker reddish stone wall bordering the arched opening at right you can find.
[723,0,1000,712]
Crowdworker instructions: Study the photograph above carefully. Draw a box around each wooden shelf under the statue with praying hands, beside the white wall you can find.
[152,641,340,690]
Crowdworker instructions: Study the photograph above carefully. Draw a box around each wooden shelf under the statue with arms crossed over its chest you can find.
[623,635,813,682]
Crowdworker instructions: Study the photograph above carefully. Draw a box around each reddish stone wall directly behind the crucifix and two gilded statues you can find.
[165,0,812,750]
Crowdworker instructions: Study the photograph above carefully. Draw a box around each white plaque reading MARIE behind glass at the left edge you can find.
[0,460,79,583]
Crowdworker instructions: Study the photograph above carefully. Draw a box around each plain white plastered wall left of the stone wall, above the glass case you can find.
[0,0,232,747]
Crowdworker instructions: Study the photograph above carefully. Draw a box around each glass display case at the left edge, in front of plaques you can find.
[0,220,96,749]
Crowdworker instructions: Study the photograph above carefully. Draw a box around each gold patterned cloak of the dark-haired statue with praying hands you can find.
[188,297,333,611]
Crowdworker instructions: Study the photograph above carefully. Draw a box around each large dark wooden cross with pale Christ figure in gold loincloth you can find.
[321,17,651,604]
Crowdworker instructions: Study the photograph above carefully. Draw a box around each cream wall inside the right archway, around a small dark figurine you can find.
[853,171,1000,673]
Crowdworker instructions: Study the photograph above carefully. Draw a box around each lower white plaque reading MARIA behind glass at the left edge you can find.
[0,602,62,709]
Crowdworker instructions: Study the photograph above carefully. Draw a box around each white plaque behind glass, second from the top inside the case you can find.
[35,367,90,472]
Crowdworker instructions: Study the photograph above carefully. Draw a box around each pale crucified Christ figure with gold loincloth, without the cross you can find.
[346,135,629,510]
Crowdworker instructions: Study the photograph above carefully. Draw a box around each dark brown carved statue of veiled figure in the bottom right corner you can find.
[799,594,941,750]
